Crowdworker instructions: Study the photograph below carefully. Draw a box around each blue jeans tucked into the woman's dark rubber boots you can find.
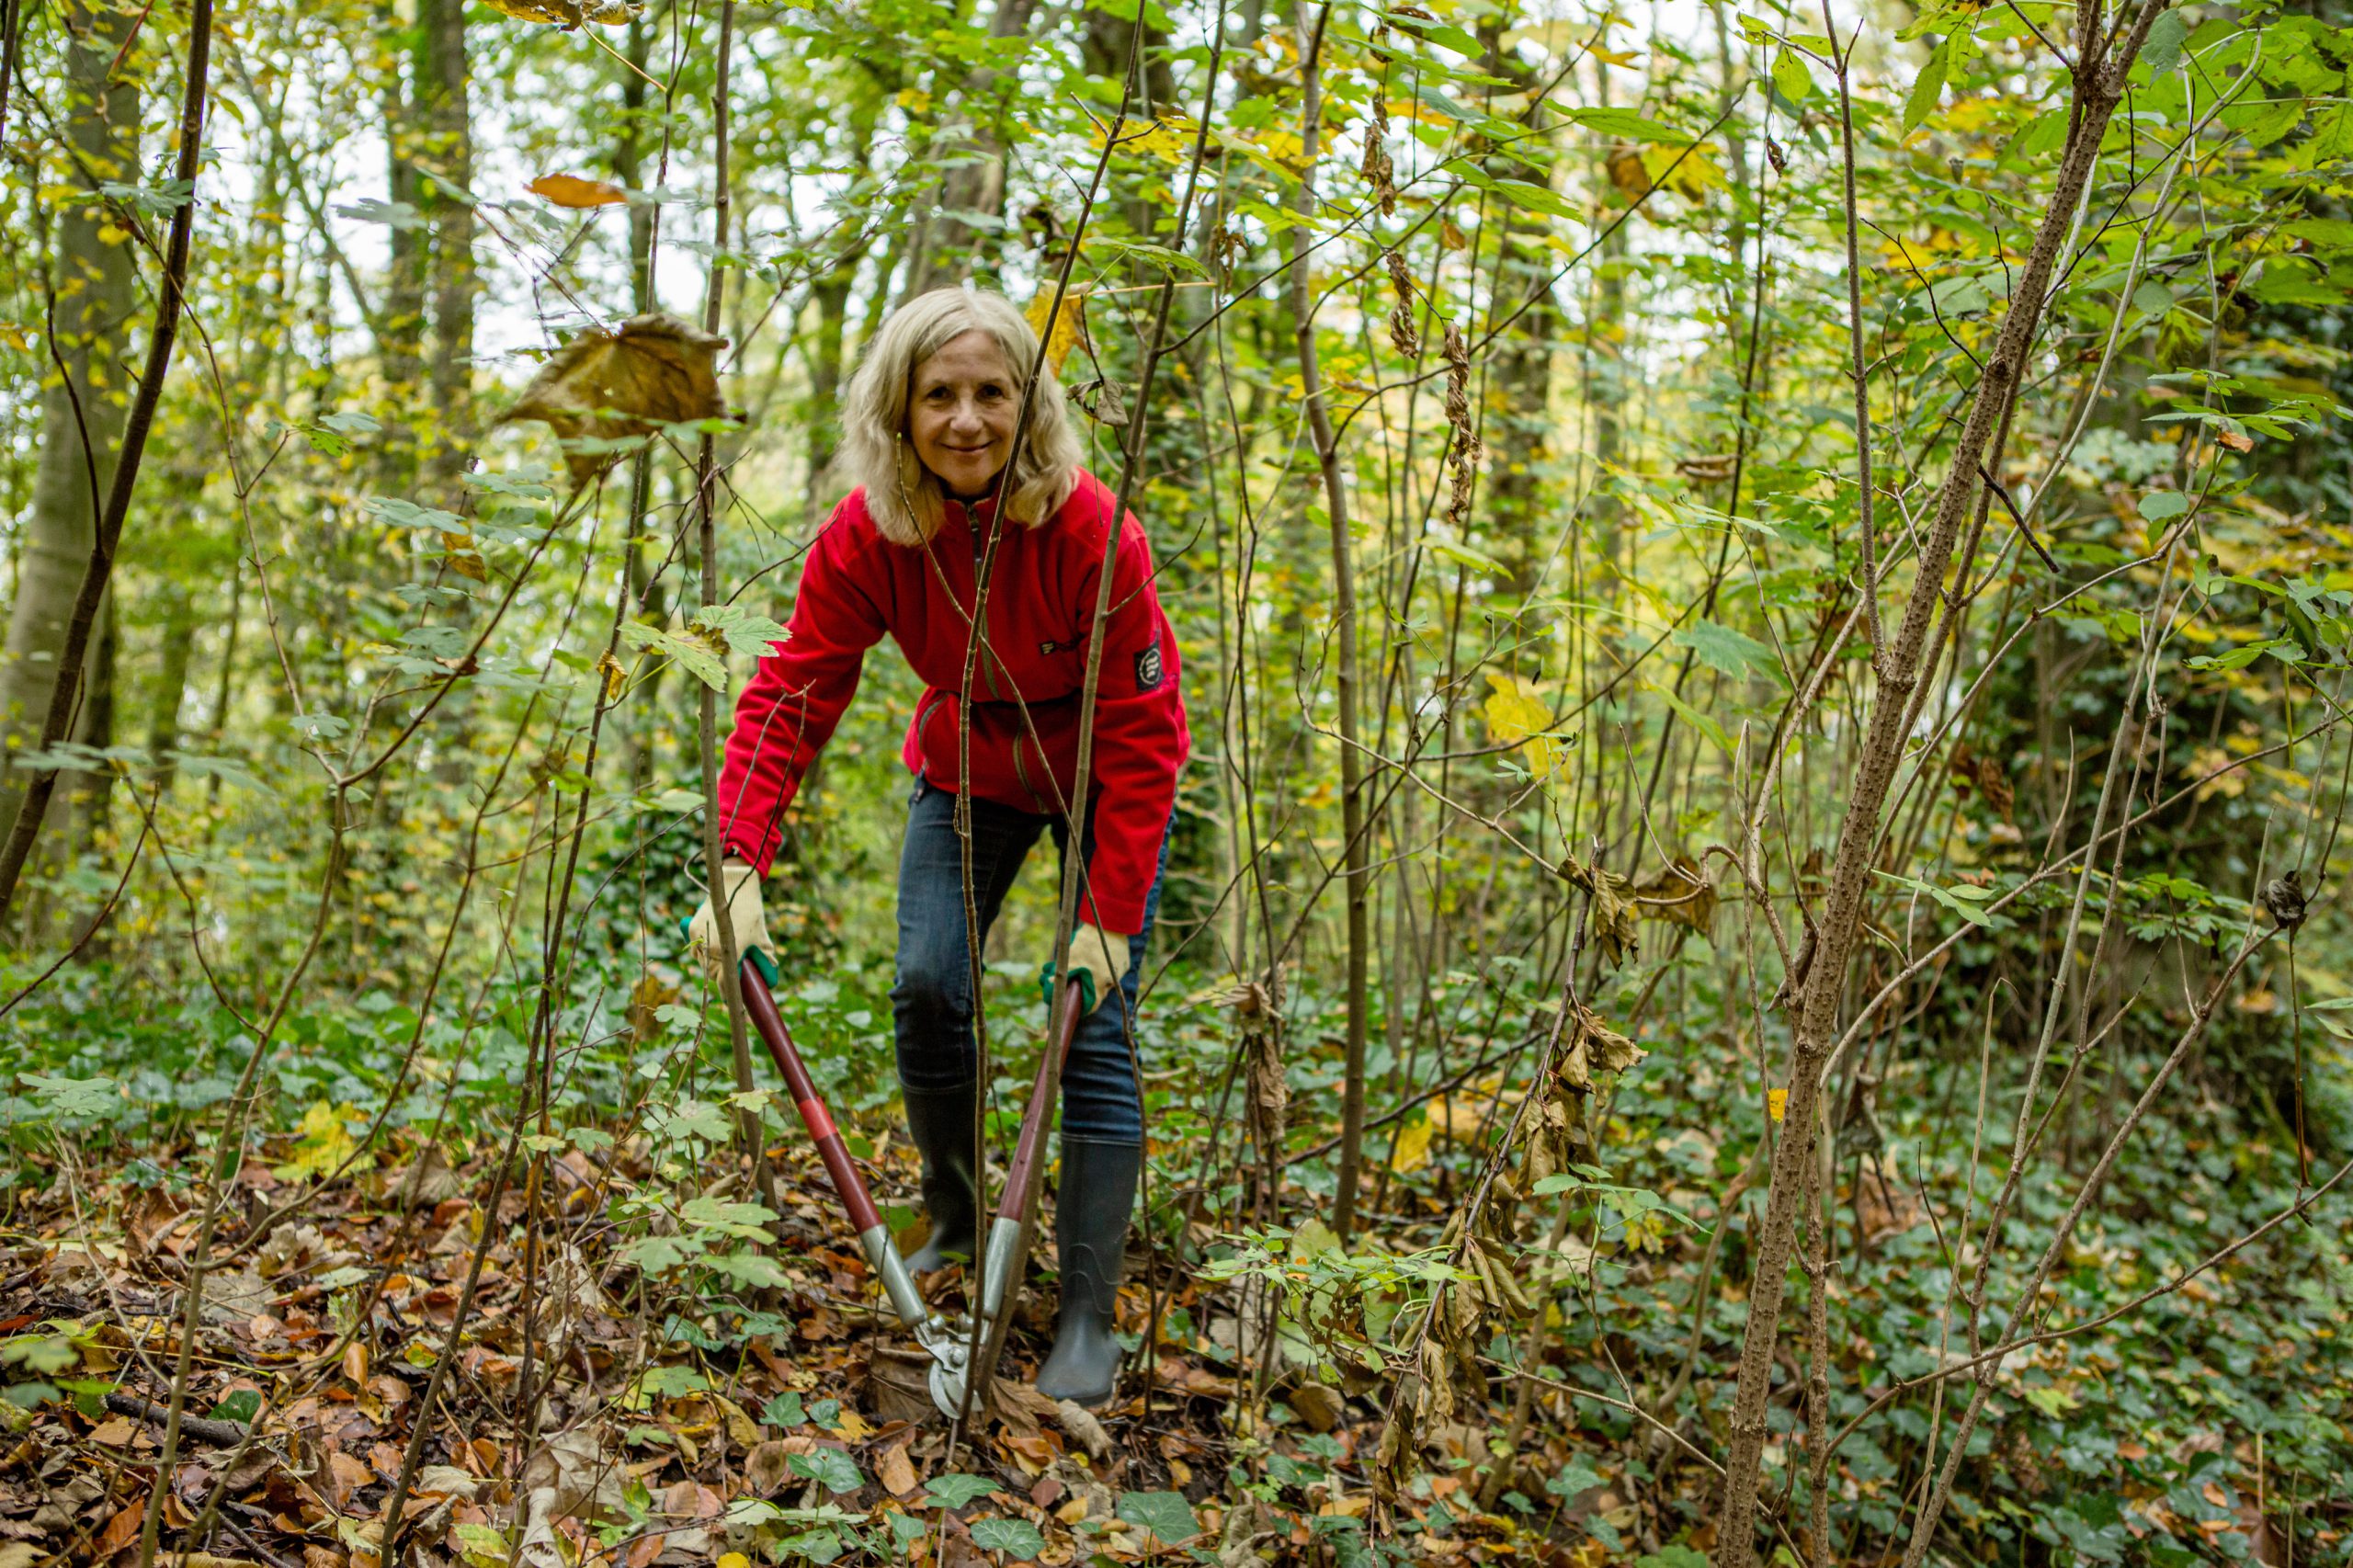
[890,779,1169,1144]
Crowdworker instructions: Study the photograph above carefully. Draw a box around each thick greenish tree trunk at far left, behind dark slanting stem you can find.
[0,0,139,861]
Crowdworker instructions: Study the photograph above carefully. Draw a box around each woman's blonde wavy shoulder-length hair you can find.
[833,288,1083,546]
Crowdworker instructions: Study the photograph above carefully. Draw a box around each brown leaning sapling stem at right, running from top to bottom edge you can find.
[1715,0,2167,1568]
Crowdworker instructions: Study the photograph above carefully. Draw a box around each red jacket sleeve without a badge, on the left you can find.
[720,502,885,876]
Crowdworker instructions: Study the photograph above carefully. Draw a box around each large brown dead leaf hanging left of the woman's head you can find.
[501,311,727,485]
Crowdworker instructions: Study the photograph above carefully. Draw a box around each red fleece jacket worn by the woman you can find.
[720,469,1190,935]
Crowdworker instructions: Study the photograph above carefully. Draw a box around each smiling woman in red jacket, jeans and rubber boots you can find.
[692,290,1188,1403]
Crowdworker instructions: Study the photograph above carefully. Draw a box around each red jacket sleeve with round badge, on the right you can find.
[1080,513,1188,937]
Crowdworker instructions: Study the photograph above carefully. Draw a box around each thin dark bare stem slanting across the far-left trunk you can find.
[0,0,211,918]
